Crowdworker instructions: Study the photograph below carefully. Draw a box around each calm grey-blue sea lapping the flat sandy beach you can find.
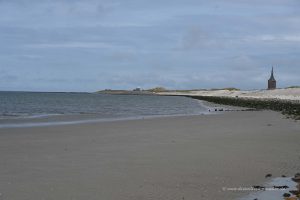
[0,92,208,128]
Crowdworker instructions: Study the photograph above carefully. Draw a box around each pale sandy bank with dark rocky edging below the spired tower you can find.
[159,88,300,120]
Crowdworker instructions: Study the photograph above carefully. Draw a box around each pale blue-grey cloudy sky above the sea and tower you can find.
[0,0,300,92]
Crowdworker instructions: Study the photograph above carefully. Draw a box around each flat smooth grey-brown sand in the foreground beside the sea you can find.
[0,111,300,200]
